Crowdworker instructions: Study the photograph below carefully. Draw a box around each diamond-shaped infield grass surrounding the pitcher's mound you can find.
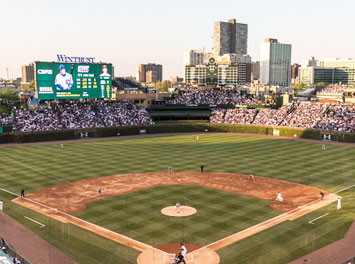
[77,185,280,245]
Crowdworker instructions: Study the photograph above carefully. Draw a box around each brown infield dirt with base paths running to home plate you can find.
[13,172,337,264]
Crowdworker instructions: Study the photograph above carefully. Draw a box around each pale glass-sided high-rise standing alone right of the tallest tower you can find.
[260,39,291,86]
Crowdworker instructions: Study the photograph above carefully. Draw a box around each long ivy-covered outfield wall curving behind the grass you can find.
[0,123,355,143]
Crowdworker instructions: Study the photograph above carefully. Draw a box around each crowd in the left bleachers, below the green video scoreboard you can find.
[0,101,153,132]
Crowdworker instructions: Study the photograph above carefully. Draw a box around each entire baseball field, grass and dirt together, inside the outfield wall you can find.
[0,133,355,264]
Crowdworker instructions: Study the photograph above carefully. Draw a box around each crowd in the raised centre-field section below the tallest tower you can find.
[169,88,263,105]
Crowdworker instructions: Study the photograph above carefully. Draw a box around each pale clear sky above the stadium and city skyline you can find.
[0,0,355,79]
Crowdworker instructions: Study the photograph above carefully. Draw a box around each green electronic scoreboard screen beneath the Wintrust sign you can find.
[35,62,112,100]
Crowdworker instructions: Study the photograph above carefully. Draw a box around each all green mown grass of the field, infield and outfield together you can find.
[0,134,355,264]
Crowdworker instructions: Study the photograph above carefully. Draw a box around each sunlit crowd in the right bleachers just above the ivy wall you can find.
[210,102,355,132]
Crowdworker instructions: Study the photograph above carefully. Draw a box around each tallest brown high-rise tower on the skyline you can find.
[213,19,248,56]
